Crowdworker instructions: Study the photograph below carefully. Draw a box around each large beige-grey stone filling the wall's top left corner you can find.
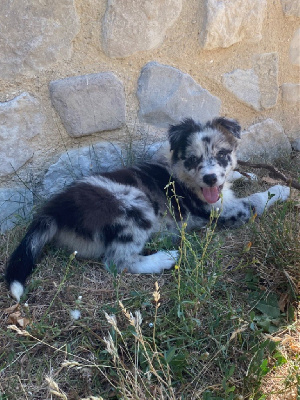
[0,0,80,79]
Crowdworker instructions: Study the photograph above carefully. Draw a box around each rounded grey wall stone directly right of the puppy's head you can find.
[237,118,291,161]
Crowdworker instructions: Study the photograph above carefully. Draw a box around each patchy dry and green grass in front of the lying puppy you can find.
[0,154,300,400]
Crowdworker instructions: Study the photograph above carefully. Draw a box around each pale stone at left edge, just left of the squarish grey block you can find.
[0,92,45,176]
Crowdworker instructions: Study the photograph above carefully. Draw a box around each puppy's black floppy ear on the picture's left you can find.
[168,118,202,151]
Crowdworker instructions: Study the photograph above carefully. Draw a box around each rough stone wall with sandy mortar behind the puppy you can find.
[0,0,300,232]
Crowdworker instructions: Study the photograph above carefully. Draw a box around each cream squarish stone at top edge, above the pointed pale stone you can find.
[199,0,267,50]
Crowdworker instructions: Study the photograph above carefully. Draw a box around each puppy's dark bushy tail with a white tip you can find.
[5,215,57,301]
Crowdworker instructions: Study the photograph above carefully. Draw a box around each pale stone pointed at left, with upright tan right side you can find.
[223,53,279,111]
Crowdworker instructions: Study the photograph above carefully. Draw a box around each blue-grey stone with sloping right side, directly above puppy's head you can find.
[137,62,221,127]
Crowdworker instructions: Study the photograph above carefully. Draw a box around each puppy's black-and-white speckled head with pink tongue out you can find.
[169,118,241,204]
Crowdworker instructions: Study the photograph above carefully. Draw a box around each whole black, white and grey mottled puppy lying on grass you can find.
[5,118,289,301]
